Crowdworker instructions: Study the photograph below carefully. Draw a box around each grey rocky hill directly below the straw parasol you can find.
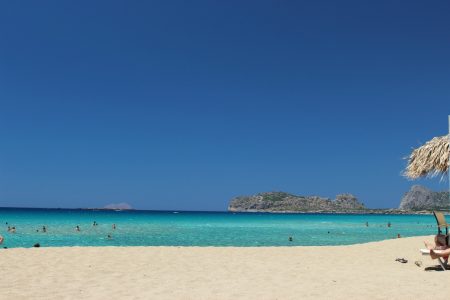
[399,185,450,210]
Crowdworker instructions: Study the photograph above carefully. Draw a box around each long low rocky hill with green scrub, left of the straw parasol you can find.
[228,192,365,212]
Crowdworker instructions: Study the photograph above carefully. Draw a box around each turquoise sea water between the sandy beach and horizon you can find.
[0,208,437,248]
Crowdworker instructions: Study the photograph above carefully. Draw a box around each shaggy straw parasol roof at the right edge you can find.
[403,135,450,179]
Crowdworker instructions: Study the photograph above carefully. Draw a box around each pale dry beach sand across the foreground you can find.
[0,236,450,300]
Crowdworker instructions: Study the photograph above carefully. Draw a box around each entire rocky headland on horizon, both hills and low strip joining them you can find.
[228,185,450,214]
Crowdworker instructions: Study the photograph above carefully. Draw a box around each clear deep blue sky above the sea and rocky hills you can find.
[0,0,450,210]
